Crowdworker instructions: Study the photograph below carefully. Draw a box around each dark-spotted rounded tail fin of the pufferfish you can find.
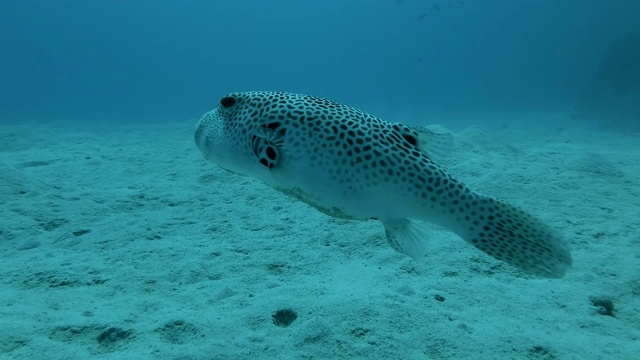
[451,194,571,278]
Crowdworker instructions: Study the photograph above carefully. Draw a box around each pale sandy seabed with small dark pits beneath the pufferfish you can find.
[0,122,640,360]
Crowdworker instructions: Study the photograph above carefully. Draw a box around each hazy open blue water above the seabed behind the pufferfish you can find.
[0,0,640,127]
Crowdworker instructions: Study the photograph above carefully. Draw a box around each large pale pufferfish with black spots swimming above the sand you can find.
[195,91,571,278]
